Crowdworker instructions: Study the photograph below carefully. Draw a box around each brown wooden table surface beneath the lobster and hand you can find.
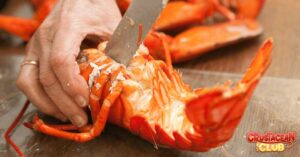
[0,0,300,157]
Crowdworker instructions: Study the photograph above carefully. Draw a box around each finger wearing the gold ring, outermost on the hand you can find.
[16,56,67,121]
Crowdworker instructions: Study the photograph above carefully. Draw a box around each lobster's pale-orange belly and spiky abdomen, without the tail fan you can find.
[81,43,202,148]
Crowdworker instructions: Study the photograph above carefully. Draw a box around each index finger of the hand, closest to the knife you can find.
[50,28,89,107]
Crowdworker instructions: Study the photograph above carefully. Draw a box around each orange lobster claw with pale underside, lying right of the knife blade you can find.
[144,19,262,63]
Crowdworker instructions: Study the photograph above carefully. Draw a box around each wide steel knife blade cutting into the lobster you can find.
[105,0,168,66]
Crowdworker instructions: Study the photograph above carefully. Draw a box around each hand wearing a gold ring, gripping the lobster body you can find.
[17,0,121,127]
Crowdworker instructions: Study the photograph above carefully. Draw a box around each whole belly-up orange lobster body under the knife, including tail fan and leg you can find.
[32,40,272,151]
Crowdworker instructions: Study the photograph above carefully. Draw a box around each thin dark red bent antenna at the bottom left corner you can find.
[4,100,30,157]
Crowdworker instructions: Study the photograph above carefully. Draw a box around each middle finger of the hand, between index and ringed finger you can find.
[24,30,87,127]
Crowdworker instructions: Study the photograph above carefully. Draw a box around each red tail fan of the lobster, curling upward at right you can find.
[185,40,273,147]
